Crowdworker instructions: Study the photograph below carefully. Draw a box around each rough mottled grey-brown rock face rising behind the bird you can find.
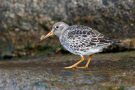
[0,0,135,54]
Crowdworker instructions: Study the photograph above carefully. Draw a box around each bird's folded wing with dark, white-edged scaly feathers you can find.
[64,25,110,51]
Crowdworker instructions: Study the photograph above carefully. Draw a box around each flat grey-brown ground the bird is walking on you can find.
[0,51,135,90]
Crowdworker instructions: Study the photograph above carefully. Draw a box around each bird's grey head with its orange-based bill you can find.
[40,22,68,40]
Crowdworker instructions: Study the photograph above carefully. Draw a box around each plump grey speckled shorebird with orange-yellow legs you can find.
[40,22,112,69]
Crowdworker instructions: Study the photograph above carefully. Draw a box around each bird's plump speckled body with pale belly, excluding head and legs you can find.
[60,25,111,55]
